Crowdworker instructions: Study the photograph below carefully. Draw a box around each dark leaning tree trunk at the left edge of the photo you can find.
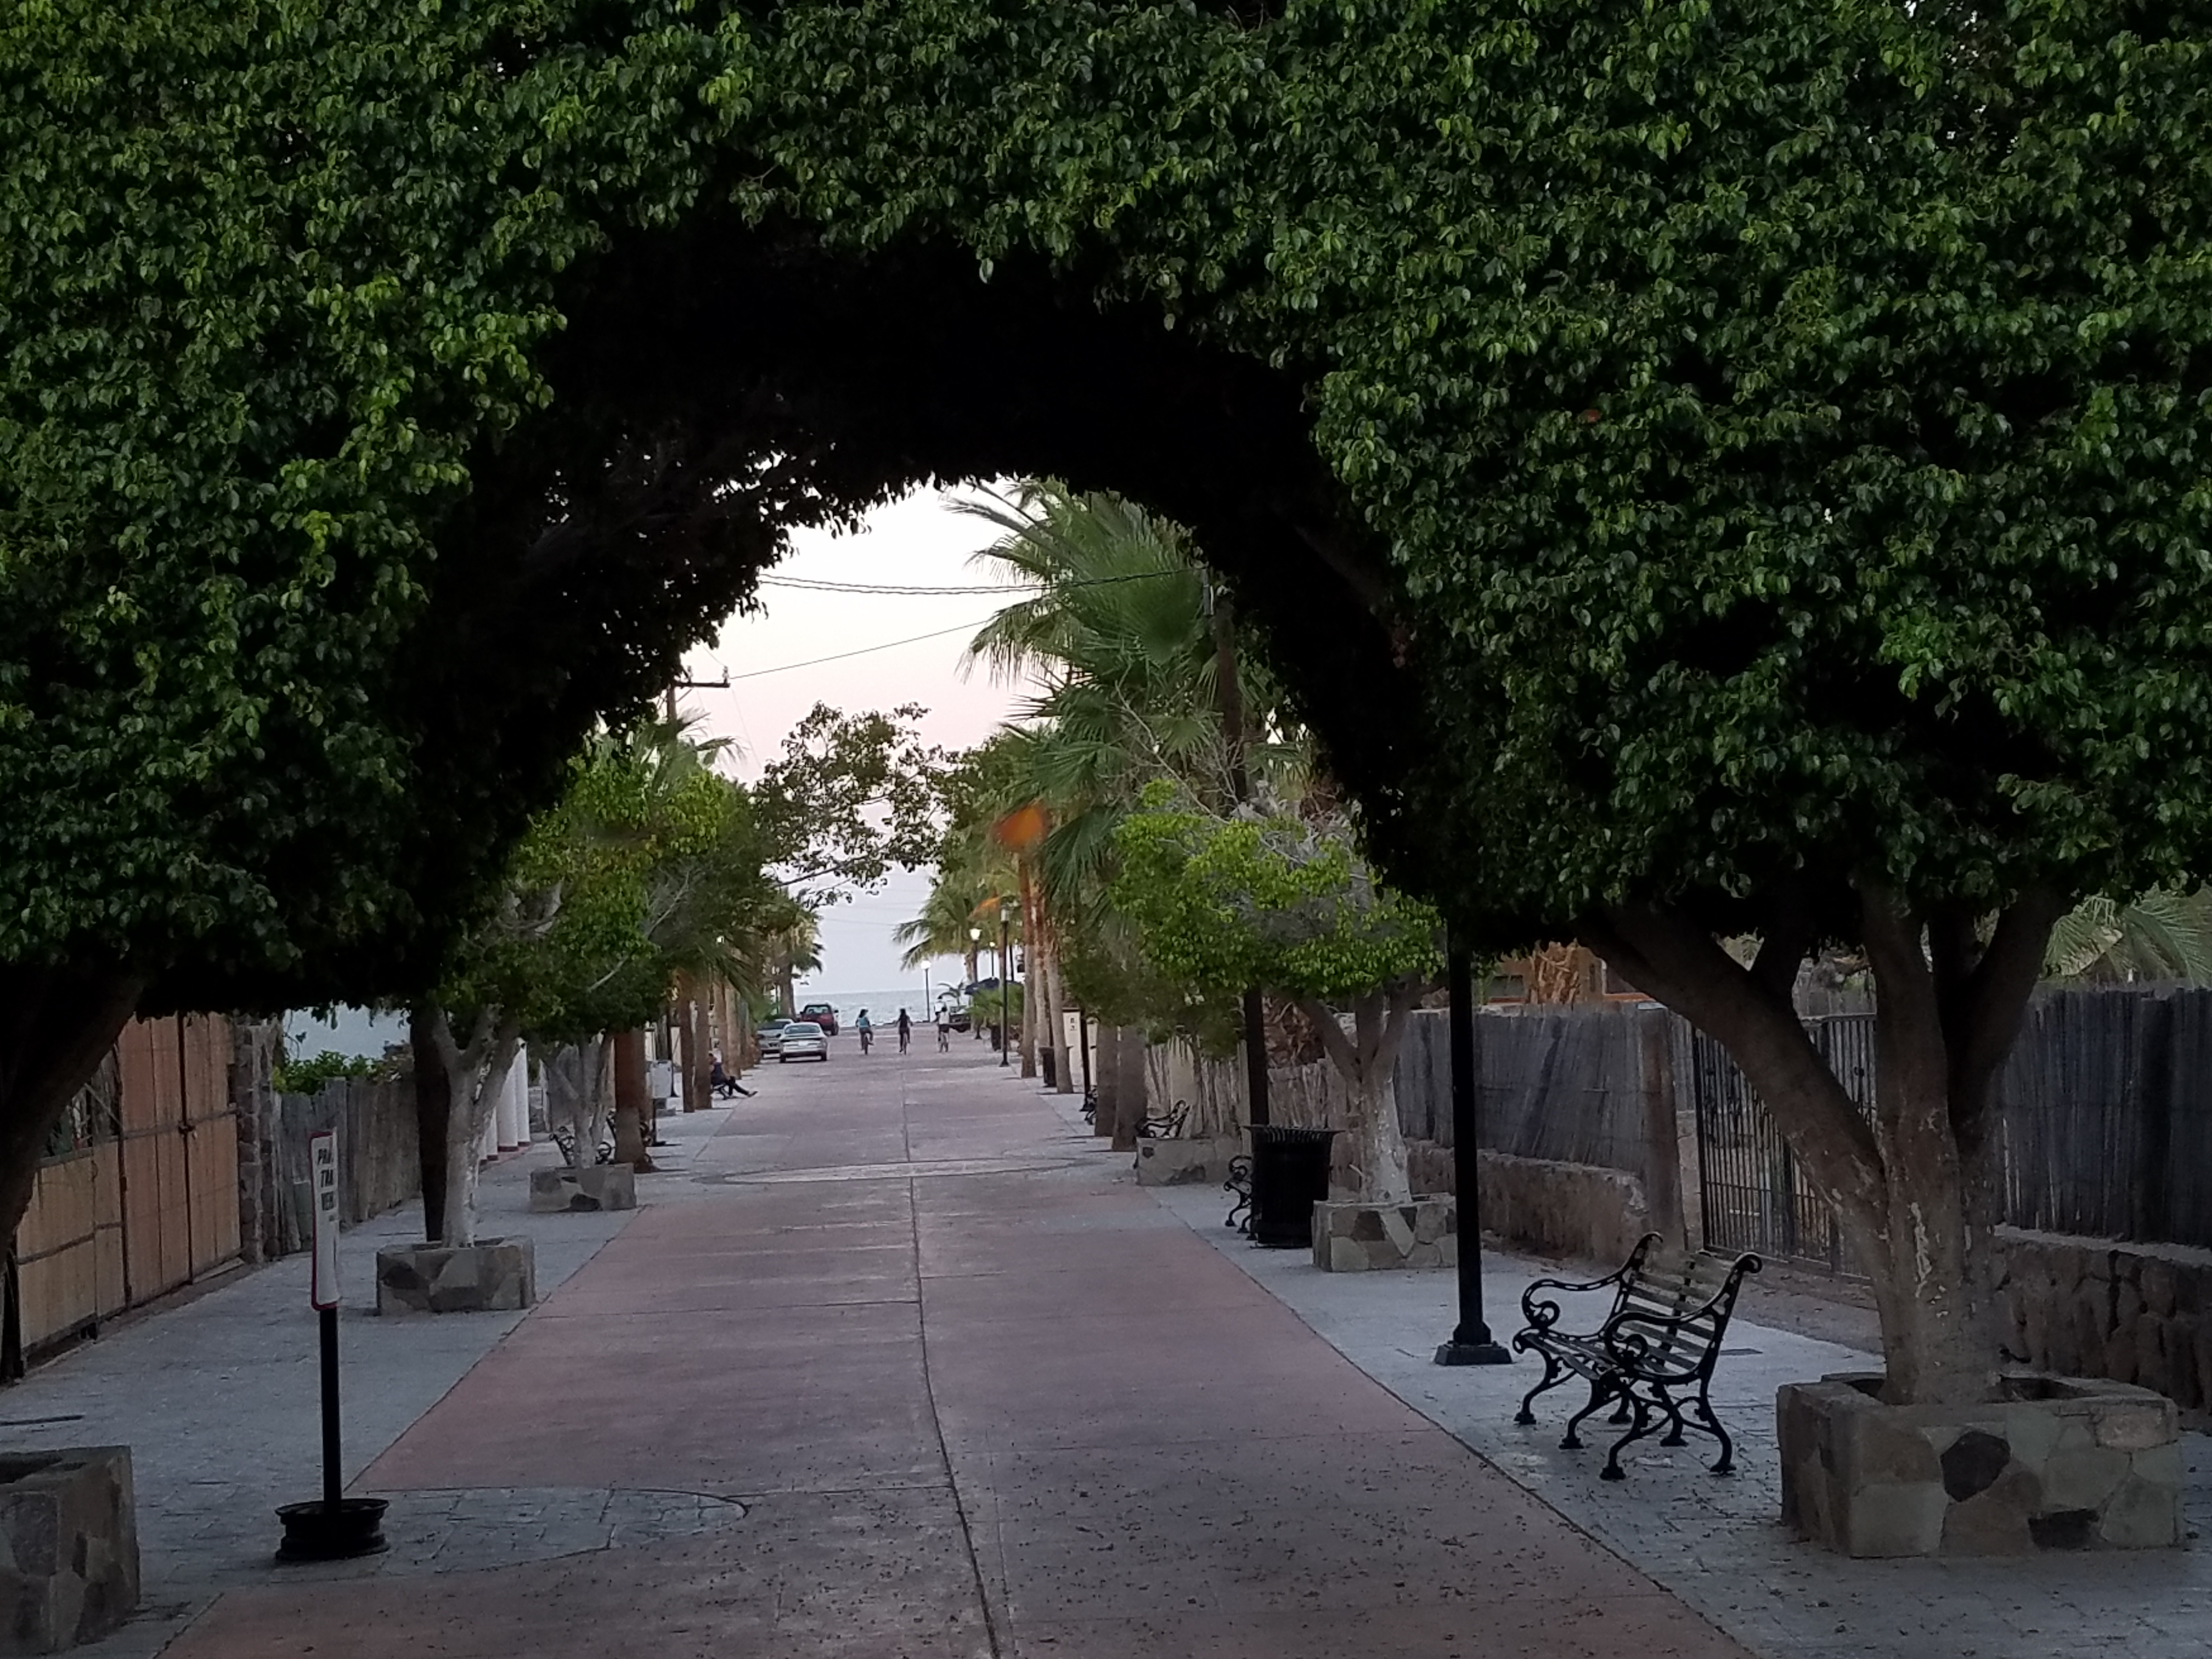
[0,964,146,1278]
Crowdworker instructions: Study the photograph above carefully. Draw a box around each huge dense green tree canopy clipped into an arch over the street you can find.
[0,0,2212,1398]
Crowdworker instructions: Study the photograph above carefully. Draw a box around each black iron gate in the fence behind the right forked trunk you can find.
[1690,1013,1874,1278]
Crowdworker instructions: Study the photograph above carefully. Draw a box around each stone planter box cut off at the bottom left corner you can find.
[0,1447,139,1652]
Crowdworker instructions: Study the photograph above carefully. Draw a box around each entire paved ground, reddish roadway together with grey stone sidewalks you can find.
[0,1042,2212,1659]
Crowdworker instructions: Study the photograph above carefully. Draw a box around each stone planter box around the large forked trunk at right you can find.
[1774,1374,2181,1555]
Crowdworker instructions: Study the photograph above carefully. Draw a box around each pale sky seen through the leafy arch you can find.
[679,479,1022,1000]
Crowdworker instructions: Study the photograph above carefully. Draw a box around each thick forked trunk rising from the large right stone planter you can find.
[1582,883,2066,1404]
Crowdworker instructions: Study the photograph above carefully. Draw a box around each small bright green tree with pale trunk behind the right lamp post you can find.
[1113,789,1440,1203]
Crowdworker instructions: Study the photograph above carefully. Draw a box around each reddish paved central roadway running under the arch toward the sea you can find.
[78,1044,1743,1659]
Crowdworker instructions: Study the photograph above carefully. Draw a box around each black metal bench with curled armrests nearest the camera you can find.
[1513,1232,1760,1480]
